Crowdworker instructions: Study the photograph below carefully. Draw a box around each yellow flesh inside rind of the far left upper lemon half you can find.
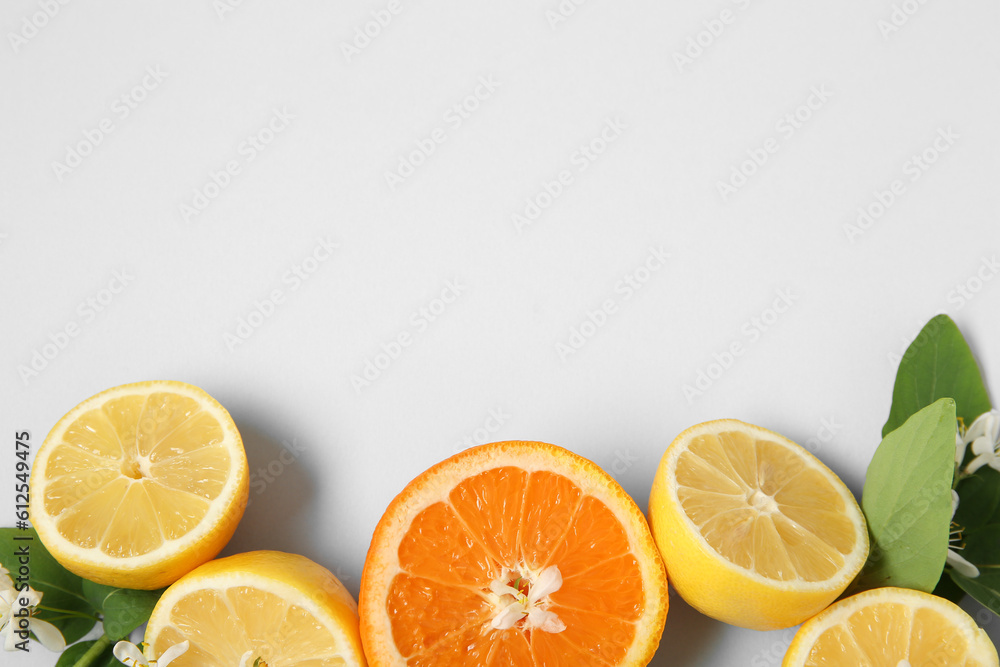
[44,392,231,558]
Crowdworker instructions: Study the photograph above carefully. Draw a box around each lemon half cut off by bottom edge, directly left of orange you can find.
[145,551,366,667]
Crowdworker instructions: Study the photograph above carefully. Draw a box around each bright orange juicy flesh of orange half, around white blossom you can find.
[386,466,645,667]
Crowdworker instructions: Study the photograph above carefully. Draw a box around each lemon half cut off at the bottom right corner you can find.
[781,588,998,667]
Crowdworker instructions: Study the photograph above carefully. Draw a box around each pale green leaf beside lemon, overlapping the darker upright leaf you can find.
[859,398,955,593]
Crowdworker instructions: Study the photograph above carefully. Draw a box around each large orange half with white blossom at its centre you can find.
[360,442,667,667]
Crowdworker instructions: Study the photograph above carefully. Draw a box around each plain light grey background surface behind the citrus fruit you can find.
[0,0,1000,667]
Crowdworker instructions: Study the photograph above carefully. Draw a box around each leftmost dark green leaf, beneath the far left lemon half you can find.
[0,528,97,644]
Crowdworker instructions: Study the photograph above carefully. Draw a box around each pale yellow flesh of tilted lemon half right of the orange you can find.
[677,432,856,581]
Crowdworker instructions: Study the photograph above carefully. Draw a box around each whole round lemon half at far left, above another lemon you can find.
[30,381,249,589]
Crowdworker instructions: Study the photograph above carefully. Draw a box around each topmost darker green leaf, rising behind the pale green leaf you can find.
[882,315,991,444]
